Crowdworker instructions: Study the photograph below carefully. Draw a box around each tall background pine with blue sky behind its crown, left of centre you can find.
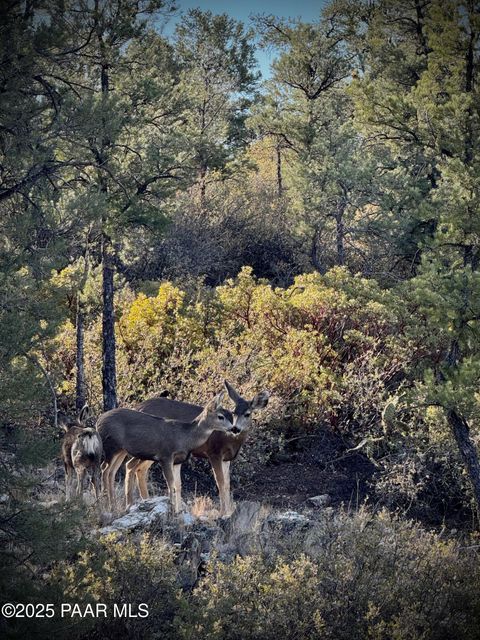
[175,9,257,201]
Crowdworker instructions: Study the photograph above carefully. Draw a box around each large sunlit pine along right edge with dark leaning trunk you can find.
[346,0,480,512]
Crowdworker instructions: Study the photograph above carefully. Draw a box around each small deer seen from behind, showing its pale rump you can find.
[61,405,103,500]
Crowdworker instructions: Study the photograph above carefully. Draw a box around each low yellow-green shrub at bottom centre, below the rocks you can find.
[177,556,324,640]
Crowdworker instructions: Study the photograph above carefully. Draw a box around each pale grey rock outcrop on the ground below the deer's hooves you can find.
[100,495,334,568]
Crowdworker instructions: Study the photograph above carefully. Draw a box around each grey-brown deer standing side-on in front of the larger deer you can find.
[97,391,233,513]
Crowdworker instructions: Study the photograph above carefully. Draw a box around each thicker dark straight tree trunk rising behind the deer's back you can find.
[102,233,117,411]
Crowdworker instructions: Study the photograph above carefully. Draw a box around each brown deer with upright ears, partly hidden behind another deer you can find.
[125,380,269,515]
